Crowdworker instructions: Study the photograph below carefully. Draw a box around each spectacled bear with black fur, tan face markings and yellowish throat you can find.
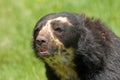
[33,12,120,80]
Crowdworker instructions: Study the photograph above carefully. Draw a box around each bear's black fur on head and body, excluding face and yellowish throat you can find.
[33,12,120,80]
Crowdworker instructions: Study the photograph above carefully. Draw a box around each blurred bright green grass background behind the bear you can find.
[0,0,120,80]
